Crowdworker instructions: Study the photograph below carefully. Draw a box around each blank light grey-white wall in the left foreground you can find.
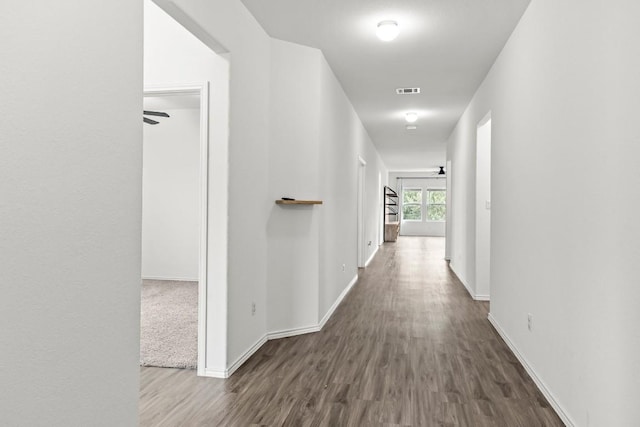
[0,0,142,426]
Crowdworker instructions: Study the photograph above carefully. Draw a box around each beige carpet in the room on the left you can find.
[140,280,198,369]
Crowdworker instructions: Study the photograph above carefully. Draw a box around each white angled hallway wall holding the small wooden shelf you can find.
[152,0,386,368]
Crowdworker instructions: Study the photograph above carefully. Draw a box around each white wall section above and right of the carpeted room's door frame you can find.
[144,0,230,372]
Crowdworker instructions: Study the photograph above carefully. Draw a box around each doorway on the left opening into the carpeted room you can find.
[141,83,209,375]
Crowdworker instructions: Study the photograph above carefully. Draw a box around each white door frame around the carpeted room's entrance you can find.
[143,82,209,376]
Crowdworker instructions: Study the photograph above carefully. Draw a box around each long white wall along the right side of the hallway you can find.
[448,0,640,426]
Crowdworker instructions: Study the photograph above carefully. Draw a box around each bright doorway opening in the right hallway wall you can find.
[475,112,491,301]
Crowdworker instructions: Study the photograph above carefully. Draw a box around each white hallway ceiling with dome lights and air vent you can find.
[242,0,529,170]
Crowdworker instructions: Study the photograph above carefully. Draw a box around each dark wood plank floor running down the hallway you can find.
[140,237,563,427]
